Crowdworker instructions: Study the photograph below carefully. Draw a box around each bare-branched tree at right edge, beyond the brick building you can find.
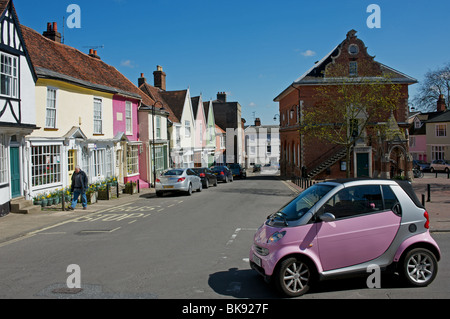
[413,63,450,112]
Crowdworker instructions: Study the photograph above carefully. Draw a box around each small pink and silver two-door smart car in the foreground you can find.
[250,179,440,297]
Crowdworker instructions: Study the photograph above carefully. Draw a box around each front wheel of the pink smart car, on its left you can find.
[275,257,313,297]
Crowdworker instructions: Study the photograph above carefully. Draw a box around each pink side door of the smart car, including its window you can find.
[317,185,401,271]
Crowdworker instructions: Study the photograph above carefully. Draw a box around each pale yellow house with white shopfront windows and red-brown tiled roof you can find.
[22,23,142,196]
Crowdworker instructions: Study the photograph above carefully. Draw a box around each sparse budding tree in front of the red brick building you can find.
[300,64,407,177]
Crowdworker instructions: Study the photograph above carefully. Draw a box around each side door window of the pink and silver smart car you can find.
[321,185,384,220]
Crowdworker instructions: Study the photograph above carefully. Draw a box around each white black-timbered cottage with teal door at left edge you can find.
[0,0,36,216]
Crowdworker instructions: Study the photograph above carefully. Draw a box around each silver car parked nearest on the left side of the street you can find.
[155,168,202,197]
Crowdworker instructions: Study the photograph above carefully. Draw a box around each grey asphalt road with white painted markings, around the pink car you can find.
[0,176,450,300]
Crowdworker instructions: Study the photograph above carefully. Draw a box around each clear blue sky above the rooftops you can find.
[13,0,450,125]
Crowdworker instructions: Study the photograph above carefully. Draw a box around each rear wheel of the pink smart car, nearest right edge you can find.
[403,248,438,287]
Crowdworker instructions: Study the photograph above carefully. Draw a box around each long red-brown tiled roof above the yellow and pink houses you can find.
[20,24,154,106]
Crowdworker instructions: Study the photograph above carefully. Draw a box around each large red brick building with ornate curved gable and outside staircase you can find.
[274,30,417,179]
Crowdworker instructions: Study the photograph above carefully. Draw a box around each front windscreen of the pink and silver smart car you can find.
[269,184,334,226]
